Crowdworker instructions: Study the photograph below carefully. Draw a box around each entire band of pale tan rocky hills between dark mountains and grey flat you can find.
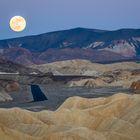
[32,59,140,88]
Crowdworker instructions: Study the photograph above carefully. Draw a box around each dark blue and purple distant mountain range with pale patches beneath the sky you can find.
[0,28,140,65]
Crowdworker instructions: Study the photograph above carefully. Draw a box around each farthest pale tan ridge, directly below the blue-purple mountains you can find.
[32,59,140,76]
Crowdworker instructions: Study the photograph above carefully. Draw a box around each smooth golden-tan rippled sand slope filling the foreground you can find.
[0,93,140,140]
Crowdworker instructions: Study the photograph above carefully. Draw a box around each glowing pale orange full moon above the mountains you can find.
[10,16,26,32]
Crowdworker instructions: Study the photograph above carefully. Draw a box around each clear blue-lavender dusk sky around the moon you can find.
[0,0,140,40]
